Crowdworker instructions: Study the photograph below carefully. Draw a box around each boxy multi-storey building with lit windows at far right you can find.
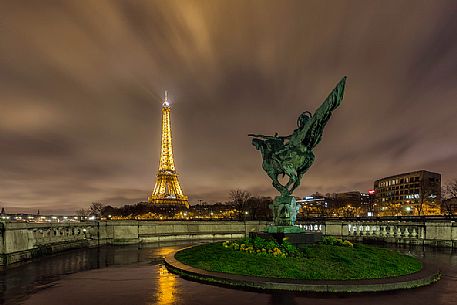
[374,170,441,215]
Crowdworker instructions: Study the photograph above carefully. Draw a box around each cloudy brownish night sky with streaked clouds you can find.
[0,0,457,213]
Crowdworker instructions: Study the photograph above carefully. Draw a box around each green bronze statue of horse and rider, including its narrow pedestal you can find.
[249,76,346,226]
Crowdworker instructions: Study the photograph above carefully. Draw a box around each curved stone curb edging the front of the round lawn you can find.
[165,247,441,293]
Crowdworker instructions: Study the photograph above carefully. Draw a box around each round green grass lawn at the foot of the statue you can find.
[175,243,422,280]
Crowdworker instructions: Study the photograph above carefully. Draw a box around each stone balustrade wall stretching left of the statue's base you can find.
[0,221,266,266]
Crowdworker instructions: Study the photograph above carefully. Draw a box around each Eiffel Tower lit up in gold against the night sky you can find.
[148,91,189,208]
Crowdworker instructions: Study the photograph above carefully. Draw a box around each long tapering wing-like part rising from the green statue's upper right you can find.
[289,76,346,149]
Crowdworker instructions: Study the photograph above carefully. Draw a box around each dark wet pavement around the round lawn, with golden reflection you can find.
[0,240,457,305]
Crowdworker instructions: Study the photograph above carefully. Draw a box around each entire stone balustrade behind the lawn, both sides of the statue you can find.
[0,218,457,266]
